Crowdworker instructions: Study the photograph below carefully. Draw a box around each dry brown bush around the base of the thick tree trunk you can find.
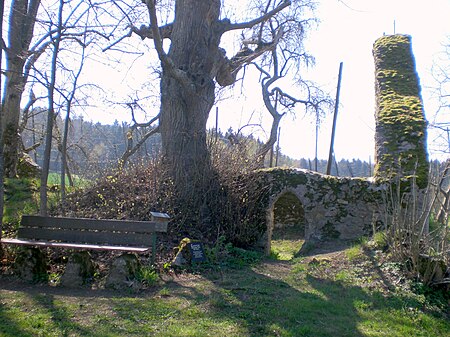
[58,136,267,246]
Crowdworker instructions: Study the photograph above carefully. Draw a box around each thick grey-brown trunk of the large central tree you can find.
[160,0,220,199]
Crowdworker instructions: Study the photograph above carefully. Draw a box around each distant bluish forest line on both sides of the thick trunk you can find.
[22,108,446,178]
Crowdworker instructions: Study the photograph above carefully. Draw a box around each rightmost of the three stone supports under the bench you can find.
[105,254,140,289]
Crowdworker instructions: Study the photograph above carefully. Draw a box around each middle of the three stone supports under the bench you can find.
[61,251,95,288]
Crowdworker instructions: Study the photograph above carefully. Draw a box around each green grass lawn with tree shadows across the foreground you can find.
[0,240,450,337]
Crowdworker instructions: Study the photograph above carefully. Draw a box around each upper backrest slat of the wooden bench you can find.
[20,215,167,233]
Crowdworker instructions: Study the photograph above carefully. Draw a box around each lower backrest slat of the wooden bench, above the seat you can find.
[17,227,152,247]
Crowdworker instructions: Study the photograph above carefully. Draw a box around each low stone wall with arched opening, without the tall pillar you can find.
[259,168,384,252]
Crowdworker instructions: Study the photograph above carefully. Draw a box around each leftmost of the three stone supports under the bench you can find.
[14,247,48,282]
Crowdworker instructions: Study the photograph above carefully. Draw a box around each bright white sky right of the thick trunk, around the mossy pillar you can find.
[205,0,450,162]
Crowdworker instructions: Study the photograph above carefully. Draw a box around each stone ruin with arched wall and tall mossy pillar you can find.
[258,35,429,252]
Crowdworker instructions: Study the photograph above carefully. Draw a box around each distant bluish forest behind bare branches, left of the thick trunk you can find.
[22,108,161,178]
